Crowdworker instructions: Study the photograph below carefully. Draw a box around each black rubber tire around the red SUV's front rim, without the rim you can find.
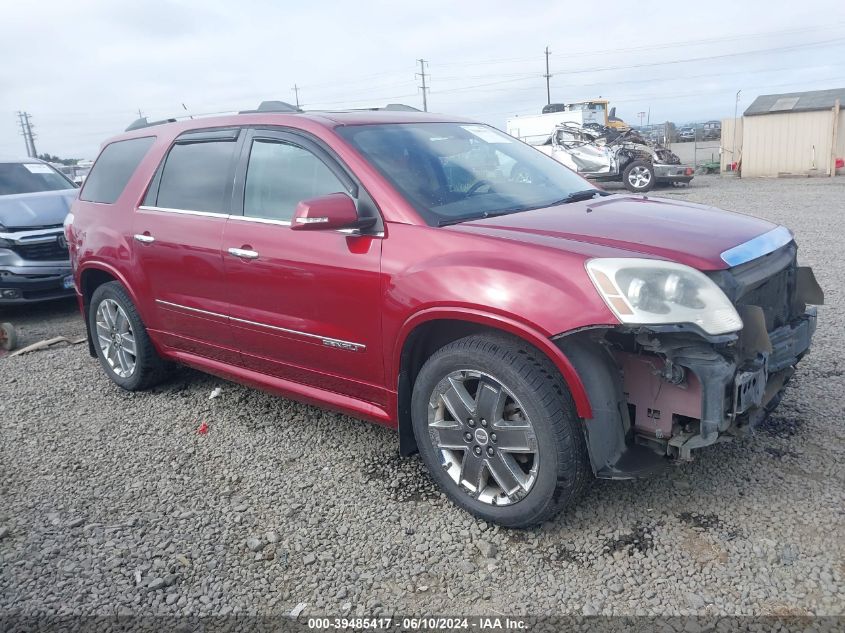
[411,334,592,528]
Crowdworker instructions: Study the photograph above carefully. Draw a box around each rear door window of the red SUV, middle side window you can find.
[156,140,238,213]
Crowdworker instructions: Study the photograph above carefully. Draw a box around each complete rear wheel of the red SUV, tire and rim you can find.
[88,281,167,391]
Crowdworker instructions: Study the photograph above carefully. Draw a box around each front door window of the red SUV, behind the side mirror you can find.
[244,140,346,222]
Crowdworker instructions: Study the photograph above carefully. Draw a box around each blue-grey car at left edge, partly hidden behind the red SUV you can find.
[0,158,78,306]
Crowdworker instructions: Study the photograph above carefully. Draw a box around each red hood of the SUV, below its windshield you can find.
[450,195,776,270]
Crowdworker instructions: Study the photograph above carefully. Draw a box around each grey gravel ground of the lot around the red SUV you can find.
[0,177,845,615]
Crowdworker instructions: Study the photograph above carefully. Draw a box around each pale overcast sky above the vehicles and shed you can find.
[0,0,845,158]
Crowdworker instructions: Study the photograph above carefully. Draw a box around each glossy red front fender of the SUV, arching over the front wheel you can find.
[382,224,618,418]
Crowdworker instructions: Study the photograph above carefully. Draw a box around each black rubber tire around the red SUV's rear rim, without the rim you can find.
[88,281,170,391]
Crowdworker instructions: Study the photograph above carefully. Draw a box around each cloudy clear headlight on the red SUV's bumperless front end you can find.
[587,257,742,335]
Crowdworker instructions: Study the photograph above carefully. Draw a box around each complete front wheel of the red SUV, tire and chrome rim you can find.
[411,335,590,528]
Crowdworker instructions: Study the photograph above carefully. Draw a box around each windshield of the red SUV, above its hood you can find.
[337,123,599,226]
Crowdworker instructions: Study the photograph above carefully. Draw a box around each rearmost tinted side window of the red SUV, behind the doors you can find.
[79,136,155,204]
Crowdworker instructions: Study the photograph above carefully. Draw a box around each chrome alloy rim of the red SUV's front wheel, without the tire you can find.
[428,370,540,505]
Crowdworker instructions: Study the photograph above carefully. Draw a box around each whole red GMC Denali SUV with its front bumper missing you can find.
[66,105,823,526]
